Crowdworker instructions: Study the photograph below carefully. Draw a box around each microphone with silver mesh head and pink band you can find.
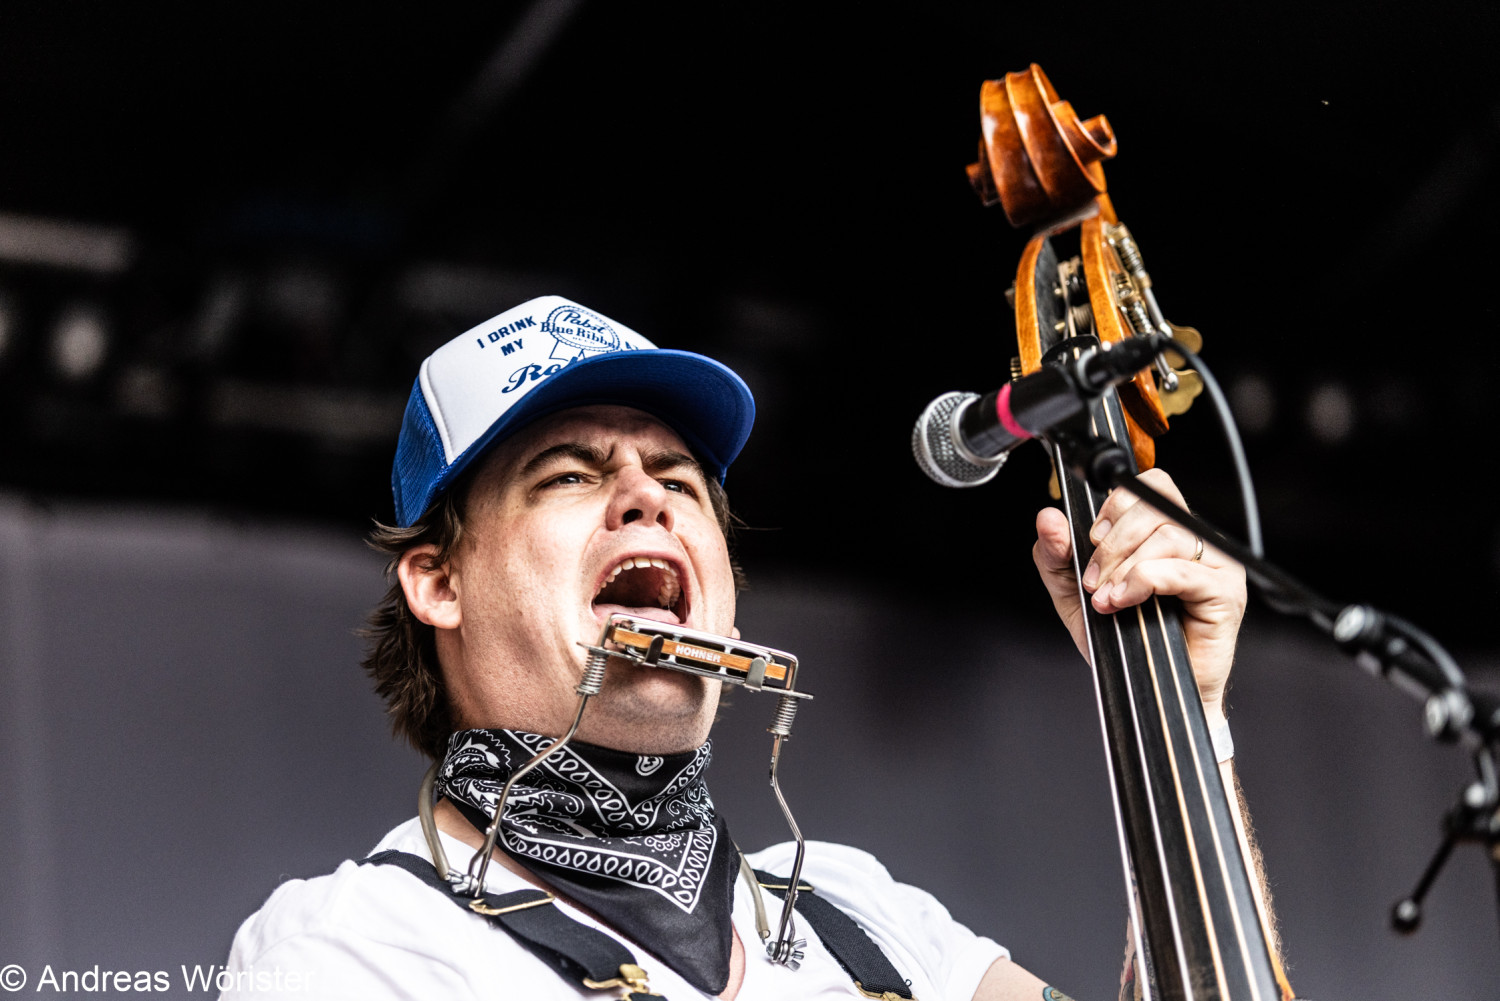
[912,336,1172,486]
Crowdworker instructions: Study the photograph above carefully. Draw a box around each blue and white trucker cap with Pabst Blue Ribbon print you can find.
[390,296,755,528]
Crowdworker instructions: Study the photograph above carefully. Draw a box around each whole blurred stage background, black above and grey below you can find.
[0,2,1500,1001]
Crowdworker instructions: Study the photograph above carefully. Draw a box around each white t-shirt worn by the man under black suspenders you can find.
[216,819,1010,1001]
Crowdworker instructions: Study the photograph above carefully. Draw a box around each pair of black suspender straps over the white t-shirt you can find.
[360,851,915,1001]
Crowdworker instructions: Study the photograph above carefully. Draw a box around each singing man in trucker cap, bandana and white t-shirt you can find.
[217,296,1245,1001]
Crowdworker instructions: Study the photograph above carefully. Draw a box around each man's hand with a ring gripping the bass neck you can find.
[1032,470,1245,725]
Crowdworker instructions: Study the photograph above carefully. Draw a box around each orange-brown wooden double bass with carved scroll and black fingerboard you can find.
[968,63,1293,1001]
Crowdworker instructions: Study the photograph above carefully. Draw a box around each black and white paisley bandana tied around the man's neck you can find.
[438,729,740,993]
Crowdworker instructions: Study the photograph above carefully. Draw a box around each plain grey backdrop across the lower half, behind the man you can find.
[0,498,1500,1001]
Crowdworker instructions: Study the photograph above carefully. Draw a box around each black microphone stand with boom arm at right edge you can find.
[1046,420,1500,933]
